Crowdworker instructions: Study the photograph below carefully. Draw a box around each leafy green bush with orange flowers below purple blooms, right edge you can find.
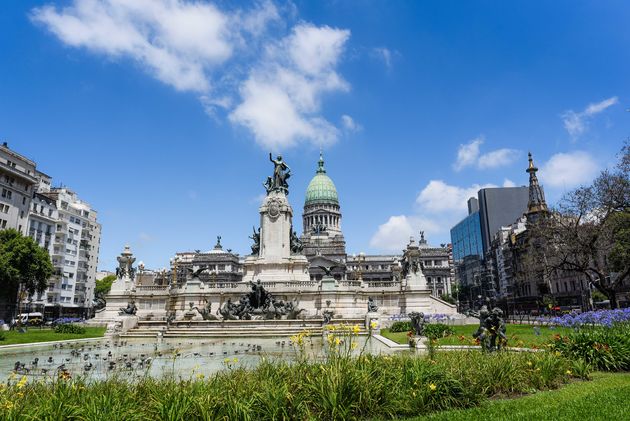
[548,322,630,371]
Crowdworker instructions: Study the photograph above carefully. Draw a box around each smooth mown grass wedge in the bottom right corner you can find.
[413,373,630,421]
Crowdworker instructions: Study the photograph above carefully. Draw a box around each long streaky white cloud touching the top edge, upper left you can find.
[31,0,238,92]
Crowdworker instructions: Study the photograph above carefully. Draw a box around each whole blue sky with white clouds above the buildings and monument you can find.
[0,0,630,269]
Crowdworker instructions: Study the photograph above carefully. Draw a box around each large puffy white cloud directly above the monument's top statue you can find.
[230,24,350,150]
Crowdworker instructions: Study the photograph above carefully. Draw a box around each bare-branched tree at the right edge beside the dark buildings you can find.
[528,140,630,308]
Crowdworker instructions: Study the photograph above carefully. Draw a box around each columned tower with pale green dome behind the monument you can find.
[301,153,346,280]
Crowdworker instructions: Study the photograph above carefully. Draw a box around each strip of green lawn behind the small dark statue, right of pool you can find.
[381,324,569,348]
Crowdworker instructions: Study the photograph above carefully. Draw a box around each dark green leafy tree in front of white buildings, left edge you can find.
[0,229,53,318]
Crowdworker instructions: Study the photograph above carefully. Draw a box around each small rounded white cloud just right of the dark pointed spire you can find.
[540,151,599,189]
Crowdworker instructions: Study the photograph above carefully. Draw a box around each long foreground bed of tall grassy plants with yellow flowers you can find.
[0,351,571,420]
